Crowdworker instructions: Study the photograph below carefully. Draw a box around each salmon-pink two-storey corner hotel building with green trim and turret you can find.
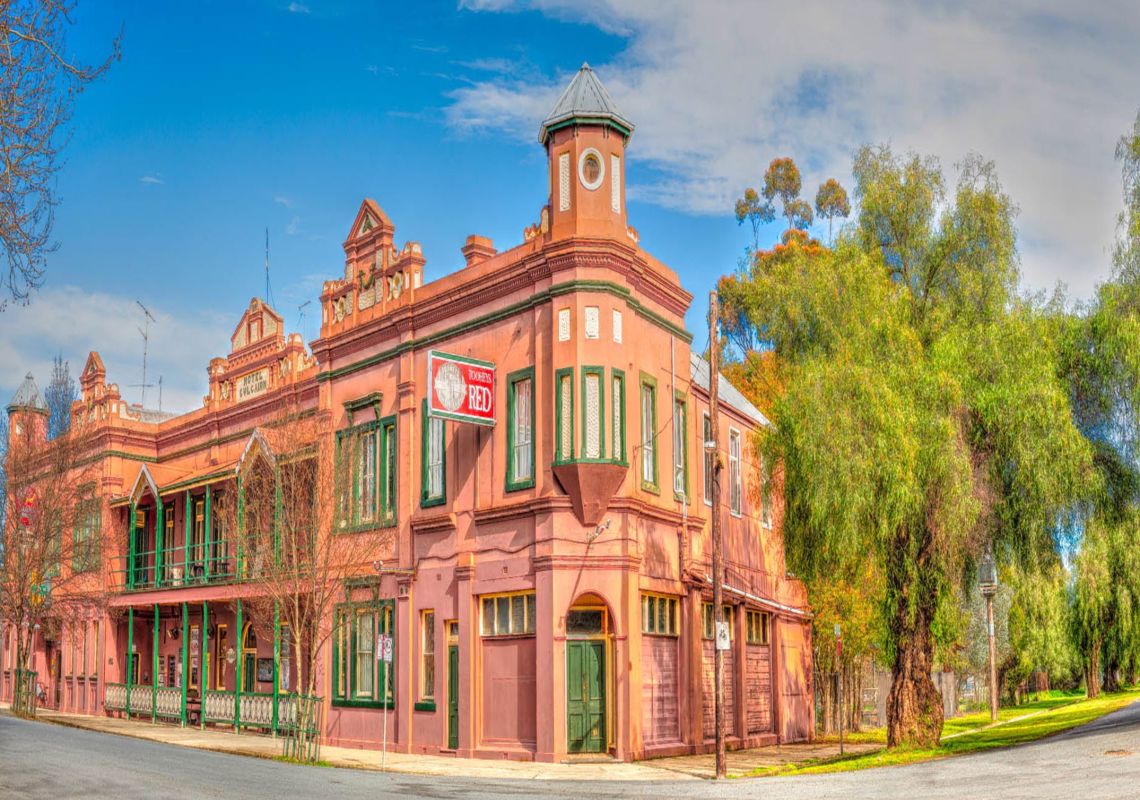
[0,66,813,761]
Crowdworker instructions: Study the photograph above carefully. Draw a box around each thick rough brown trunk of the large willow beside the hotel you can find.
[887,532,943,748]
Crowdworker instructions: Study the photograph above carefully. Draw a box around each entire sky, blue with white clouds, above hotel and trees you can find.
[0,0,1140,410]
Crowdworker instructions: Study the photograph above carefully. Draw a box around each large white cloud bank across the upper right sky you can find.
[448,0,1140,295]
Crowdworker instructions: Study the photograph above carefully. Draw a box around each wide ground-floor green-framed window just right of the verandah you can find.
[333,599,396,708]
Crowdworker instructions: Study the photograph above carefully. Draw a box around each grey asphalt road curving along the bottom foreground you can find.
[0,702,1140,800]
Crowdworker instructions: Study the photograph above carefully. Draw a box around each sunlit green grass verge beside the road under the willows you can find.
[750,688,1140,776]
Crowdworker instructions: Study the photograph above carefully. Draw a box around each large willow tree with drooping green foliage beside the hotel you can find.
[747,147,1091,746]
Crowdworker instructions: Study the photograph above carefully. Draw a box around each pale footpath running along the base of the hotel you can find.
[0,703,880,782]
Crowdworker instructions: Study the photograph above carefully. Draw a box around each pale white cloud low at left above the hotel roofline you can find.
[0,286,231,413]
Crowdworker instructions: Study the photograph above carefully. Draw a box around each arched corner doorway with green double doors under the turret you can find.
[565,595,612,753]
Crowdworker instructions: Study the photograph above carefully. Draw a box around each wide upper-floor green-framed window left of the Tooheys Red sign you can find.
[335,415,399,531]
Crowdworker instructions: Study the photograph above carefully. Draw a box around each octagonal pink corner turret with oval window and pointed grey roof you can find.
[538,64,634,242]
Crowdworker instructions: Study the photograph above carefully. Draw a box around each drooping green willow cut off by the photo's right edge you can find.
[1058,109,1140,695]
